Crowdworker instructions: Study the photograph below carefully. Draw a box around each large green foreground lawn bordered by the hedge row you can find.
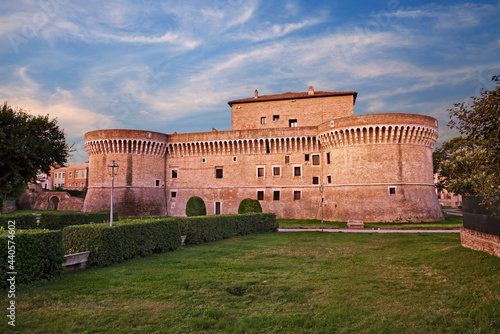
[0,232,500,333]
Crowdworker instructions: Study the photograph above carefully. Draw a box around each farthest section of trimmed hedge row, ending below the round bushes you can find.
[177,213,279,245]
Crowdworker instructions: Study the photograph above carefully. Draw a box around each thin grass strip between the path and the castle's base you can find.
[278,215,463,230]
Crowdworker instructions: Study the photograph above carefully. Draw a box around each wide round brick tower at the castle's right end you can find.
[319,114,444,222]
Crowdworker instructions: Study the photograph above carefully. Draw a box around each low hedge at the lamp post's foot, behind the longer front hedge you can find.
[39,211,118,230]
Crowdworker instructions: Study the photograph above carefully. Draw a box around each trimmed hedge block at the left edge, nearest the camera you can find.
[0,230,64,289]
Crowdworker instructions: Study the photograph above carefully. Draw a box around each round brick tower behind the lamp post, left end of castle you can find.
[83,130,167,217]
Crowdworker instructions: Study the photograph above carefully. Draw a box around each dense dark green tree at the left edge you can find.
[0,102,70,211]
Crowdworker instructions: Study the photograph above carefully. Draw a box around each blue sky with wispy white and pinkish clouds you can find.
[0,0,500,163]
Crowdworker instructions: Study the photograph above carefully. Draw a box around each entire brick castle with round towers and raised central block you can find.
[83,87,443,222]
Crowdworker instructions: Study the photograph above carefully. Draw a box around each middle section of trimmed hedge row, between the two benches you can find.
[62,218,181,267]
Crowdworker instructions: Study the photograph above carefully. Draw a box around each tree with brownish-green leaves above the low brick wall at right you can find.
[434,75,500,207]
